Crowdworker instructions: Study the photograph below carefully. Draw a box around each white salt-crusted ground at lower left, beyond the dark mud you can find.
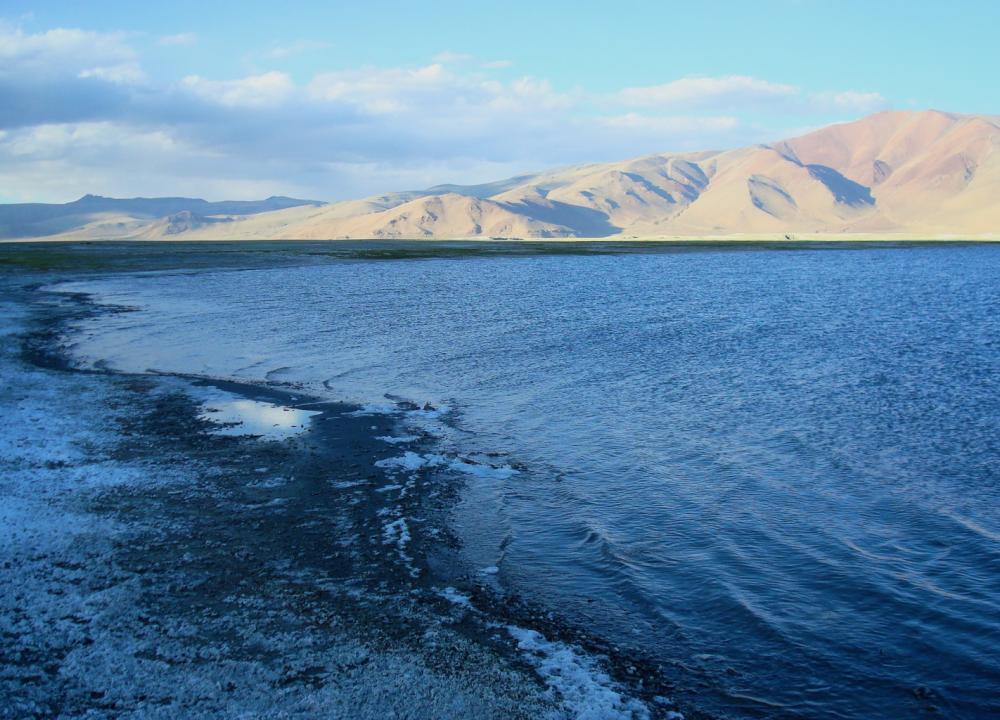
[0,288,564,720]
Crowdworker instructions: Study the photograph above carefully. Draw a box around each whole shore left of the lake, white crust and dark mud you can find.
[0,278,700,718]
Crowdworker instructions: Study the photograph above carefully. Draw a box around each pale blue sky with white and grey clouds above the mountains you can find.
[0,0,1000,202]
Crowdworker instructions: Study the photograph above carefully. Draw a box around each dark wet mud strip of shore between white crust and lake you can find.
[0,272,706,720]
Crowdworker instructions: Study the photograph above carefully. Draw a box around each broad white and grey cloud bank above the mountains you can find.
[0,24,883,200]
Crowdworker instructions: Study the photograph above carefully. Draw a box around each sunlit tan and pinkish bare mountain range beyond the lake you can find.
[0,110,1000,240]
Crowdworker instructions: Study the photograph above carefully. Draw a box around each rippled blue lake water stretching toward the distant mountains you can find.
[58,247,1000,718]
